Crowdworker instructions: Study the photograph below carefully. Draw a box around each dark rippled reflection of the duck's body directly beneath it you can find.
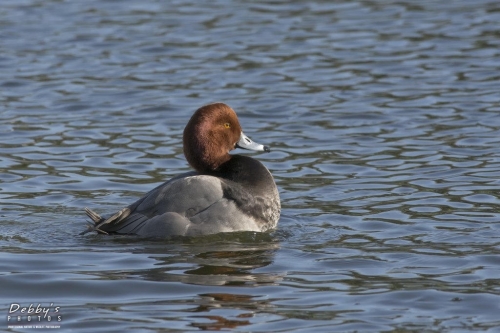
[116,231,283,286]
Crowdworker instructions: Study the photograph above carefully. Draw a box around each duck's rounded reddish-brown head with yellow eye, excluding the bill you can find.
[183,103,242,172]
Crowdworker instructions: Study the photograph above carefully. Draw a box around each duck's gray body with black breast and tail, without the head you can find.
[86,155,281,237]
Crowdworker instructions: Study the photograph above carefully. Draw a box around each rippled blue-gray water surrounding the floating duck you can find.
[0,0,500,332]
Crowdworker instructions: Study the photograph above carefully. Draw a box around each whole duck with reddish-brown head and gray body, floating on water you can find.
[84,103,281,237]
